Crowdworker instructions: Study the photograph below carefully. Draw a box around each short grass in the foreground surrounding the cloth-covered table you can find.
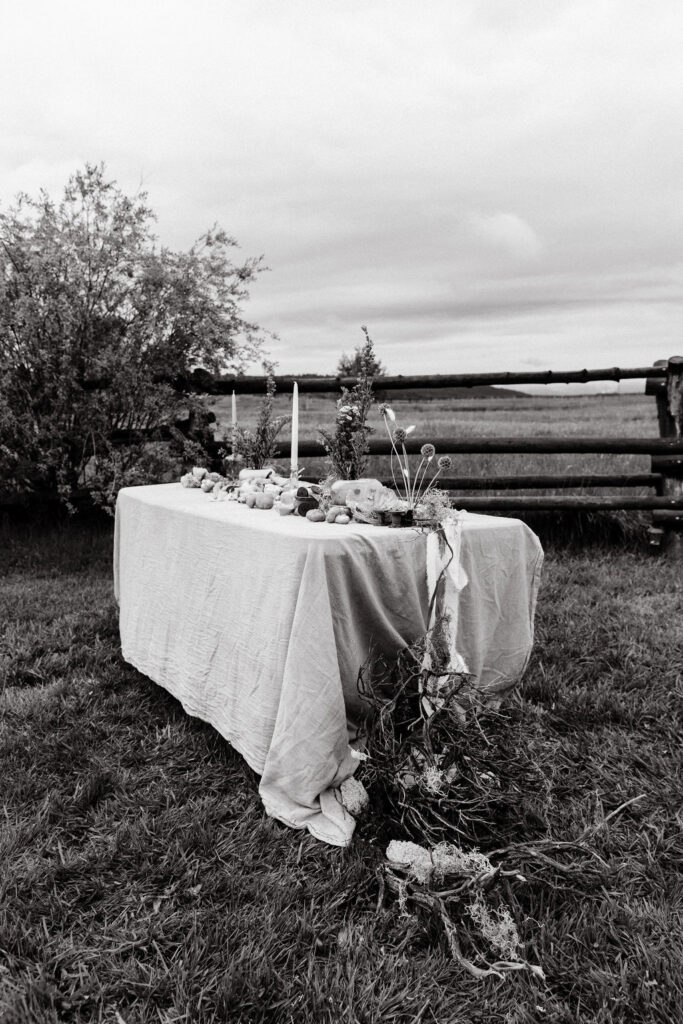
[0,393,683,1024]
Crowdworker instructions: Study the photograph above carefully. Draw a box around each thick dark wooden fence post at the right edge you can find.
[646,355,683,557]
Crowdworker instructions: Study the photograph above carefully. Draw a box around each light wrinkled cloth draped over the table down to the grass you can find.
[114,483,543,846]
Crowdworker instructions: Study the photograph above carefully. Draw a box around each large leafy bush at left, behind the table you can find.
[0,165,263,503]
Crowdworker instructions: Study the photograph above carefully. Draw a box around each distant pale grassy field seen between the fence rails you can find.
[213,394,658,495]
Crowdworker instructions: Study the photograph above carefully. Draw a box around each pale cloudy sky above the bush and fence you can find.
[0,0,683,382]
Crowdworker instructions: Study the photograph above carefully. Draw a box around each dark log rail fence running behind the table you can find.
[183,356,683,548]
